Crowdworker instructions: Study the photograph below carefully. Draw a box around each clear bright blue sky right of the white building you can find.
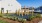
[17,0,42,7]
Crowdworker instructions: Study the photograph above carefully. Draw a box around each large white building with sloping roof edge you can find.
[0,0,21,13]
